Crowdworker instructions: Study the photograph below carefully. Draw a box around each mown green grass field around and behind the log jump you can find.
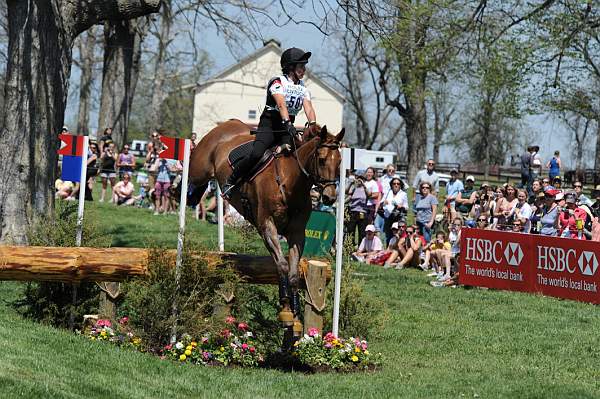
[0,198,600,398]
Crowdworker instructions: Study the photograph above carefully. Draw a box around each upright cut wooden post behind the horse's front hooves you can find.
[304,260,329,334]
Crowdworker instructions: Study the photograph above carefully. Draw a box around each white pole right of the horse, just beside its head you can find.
[333,148,350,337]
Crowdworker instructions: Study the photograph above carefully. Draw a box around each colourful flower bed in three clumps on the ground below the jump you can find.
[84,316,381,372]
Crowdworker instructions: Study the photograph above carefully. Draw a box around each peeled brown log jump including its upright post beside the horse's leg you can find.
[0,246,331,331]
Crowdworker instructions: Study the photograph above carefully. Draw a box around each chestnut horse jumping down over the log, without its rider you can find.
[190,120,344,336]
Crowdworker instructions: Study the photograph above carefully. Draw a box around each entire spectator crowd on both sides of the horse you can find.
[56,133,600,287]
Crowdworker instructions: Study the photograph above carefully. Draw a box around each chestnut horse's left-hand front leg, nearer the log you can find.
[260,218,297,327]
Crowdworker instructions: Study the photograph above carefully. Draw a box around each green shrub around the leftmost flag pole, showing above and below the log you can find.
[12,201,111,328]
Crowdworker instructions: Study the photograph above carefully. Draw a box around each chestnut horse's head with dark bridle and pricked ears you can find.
[309,126,344,205]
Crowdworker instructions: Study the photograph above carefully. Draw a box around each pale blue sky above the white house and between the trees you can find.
[65,4,574,167]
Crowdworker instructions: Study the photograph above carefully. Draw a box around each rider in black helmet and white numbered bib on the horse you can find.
[222,47,316,199]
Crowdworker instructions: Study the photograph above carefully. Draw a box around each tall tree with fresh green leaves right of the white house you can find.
[338,0,477,179]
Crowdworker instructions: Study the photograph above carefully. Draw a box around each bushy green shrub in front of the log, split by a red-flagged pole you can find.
[117,246,239,350]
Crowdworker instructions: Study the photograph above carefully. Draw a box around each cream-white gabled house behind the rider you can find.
[188,40,344,139]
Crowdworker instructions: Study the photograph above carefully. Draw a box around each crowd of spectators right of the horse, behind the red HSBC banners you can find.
[345,152,600,287]
